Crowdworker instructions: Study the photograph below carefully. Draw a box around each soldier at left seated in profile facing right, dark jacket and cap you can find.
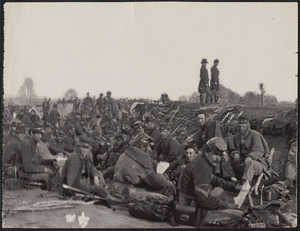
[19,124,60,191]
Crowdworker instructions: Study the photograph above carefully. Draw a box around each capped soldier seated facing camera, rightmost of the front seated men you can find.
[221,114,270,184]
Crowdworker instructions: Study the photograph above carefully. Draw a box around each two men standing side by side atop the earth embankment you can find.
[198,59,220,105]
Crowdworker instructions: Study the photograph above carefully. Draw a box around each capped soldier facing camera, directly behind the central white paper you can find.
[157,122,182,163]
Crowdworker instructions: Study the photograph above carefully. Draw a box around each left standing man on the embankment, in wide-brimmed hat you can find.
[198,59,209,105]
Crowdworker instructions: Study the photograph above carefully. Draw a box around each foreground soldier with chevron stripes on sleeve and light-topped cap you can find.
[179,137,238,227]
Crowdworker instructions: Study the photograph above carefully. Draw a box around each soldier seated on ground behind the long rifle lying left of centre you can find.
[61,136,108,197]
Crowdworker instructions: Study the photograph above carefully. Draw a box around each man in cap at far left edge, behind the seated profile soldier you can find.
[4,125,26,165]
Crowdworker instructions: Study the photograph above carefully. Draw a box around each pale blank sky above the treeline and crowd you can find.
[4,2,298,101]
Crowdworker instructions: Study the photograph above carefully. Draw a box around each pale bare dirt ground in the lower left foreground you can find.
[2,188,191,228]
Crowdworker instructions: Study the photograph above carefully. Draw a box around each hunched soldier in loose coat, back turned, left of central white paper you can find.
[114,133,175,198]
